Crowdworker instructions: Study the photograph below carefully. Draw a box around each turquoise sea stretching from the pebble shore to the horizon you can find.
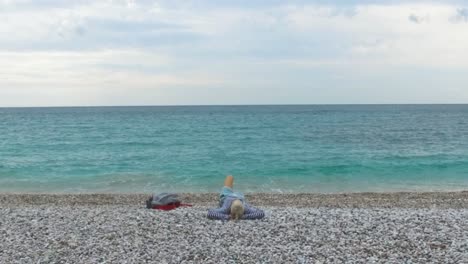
[0,105,468,193]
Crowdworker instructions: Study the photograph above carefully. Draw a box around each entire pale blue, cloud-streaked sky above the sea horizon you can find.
[0,0,468,107]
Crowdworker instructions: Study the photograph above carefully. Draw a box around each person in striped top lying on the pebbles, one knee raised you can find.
[208,176,265,220]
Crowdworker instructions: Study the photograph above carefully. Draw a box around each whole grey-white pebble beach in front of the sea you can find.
[0,192,468,263]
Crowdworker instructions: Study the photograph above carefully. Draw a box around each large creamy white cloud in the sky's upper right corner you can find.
[289,4,468,68]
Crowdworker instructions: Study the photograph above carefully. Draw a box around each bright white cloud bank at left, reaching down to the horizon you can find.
[0,50,222,106]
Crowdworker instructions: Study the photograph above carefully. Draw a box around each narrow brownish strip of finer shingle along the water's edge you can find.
[0,191,468,209]
